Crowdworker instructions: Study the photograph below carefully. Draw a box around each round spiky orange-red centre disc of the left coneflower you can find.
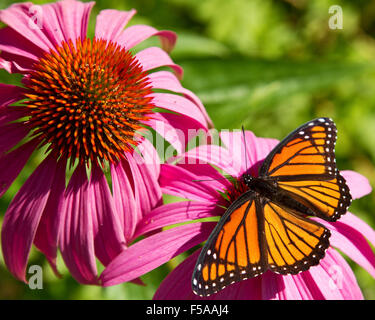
[26,38,154,163]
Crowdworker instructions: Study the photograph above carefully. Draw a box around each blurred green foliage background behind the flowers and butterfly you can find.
[0,0,375,299]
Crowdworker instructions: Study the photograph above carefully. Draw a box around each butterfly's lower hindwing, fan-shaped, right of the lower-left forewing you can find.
[263,200,330,274]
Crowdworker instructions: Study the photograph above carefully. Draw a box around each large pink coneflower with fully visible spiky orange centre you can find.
[0,0,210,284]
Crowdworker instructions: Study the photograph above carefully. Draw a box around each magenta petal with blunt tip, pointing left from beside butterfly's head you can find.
[159,164,225,204]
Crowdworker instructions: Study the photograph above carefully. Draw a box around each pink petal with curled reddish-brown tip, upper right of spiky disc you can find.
[116,25,177,52]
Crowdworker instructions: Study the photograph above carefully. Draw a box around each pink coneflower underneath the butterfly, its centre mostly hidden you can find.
[101,132,375,299]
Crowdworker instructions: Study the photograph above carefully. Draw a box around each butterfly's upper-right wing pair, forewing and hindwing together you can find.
[259,118,351,221]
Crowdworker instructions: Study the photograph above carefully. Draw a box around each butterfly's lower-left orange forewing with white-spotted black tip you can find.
[192,191,267,296]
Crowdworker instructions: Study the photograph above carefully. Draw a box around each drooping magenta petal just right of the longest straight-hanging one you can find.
[88,164,126,265]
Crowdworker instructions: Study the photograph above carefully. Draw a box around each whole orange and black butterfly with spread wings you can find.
[192,118,352,296]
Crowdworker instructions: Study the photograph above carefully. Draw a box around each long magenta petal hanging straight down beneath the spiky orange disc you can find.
[59,165,97,284]
